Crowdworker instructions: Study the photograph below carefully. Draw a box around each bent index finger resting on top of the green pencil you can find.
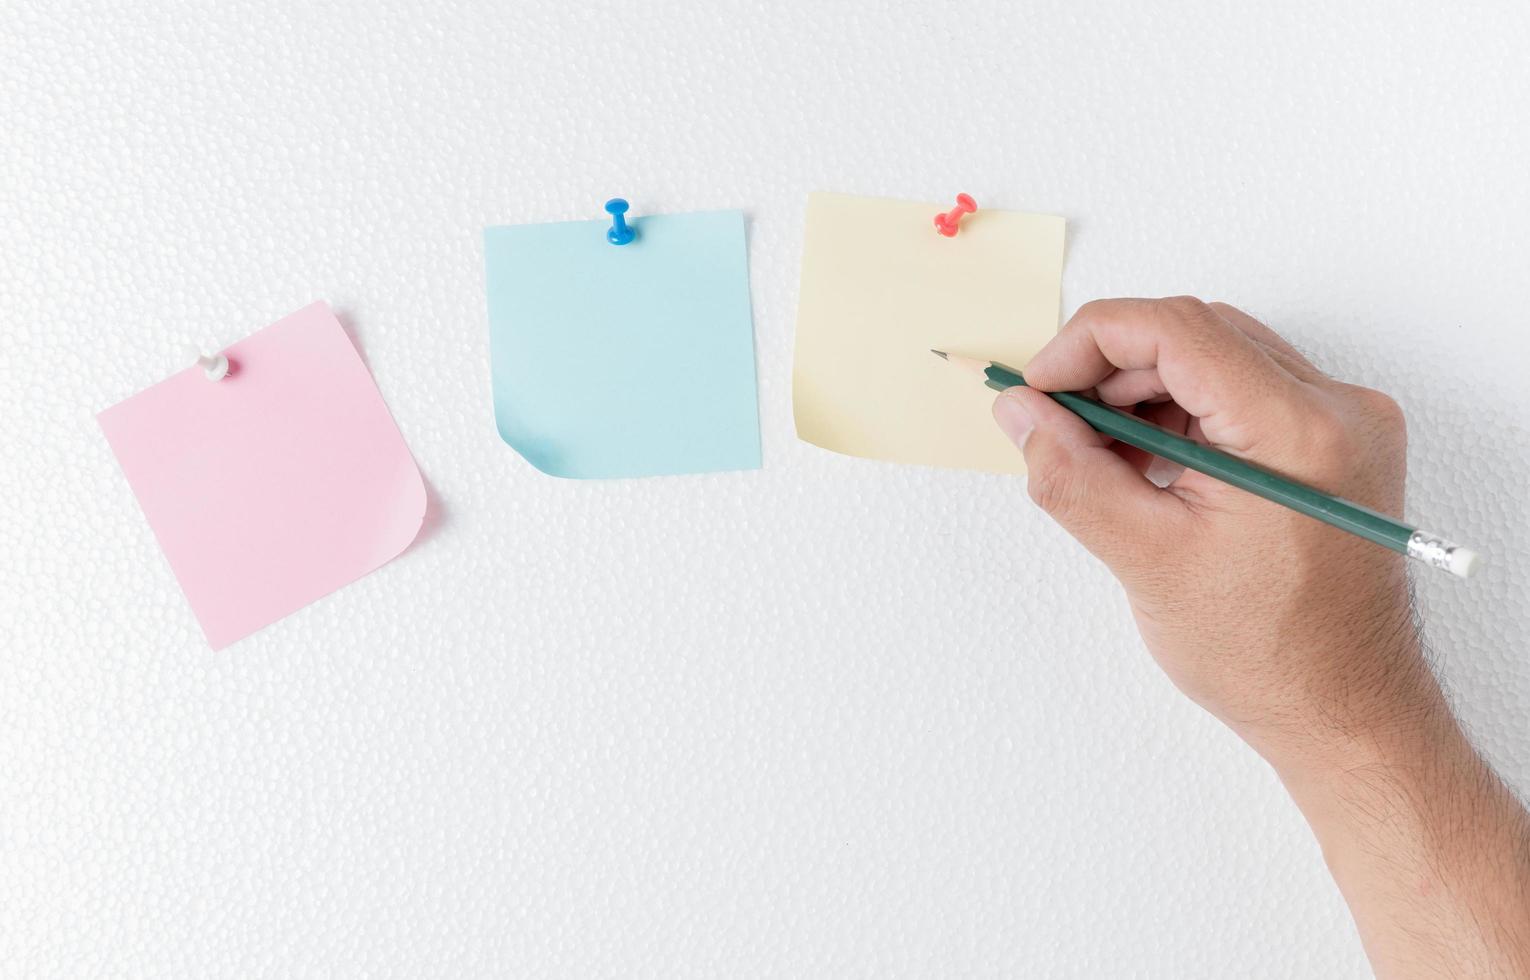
[1025,297,1320,463]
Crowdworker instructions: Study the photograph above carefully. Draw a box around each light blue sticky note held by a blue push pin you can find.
[483,211,760,480]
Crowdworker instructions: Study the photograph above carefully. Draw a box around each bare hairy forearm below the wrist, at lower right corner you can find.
[1268,685,1530,978]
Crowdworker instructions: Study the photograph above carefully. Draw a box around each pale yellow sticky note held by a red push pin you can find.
[793,194,1063,472]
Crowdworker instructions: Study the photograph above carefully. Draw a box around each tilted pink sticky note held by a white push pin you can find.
[98,303,425,650]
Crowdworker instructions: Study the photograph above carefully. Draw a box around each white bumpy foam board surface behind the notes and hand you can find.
[0,0,1530,977]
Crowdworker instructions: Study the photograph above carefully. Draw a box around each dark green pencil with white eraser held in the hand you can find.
[930,350,1478,578]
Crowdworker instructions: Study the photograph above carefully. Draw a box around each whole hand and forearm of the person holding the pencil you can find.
[993,297,1530,977]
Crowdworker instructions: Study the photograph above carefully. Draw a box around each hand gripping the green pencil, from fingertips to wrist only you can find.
[995,297,1443,766]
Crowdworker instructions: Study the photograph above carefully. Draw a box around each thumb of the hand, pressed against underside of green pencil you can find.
[993,387,1183,565]
